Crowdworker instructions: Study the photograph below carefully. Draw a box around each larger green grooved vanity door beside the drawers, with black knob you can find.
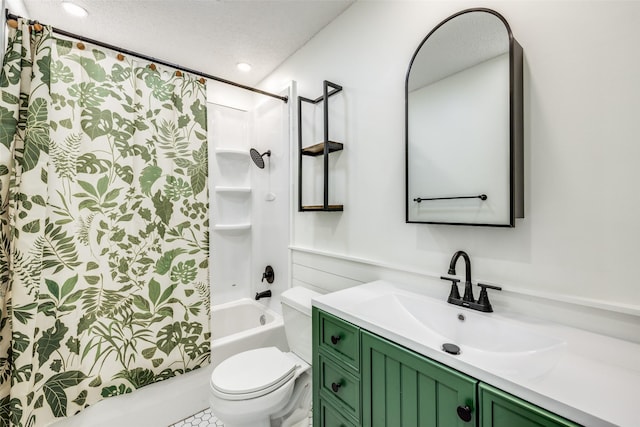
[361,331,478,427]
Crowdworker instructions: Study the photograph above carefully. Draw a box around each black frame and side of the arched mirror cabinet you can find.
[404,8,524,228]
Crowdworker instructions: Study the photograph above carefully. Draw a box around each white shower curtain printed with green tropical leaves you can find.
[0,21,210,427]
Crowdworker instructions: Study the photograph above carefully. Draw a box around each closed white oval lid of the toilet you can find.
[211,347,297,400]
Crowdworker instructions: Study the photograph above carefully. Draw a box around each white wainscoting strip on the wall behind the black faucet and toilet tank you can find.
[290,247,640,343]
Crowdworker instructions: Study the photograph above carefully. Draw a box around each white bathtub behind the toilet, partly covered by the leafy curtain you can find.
[52,298,288,427]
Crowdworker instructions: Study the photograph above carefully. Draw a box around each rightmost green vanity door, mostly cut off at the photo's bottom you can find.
[478,383,579,427]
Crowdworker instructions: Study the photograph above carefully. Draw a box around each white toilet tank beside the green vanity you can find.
[280,286,321,364]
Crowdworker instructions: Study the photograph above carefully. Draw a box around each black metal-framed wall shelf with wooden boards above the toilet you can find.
[298,80,344,212]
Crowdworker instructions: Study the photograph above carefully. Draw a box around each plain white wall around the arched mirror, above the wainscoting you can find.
[263,1,640,321]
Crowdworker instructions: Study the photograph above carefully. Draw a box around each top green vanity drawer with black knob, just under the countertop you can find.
[319,311,360,372]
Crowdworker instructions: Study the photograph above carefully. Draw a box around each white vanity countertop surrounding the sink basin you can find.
[313,280,640,427]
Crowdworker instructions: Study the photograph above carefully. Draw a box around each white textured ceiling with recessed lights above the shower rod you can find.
[15,0,354,85]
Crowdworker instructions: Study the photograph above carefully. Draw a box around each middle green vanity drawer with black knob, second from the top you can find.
[319,354,360,419]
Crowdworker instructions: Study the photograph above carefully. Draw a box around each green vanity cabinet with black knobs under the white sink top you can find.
[312,307,579,427]
